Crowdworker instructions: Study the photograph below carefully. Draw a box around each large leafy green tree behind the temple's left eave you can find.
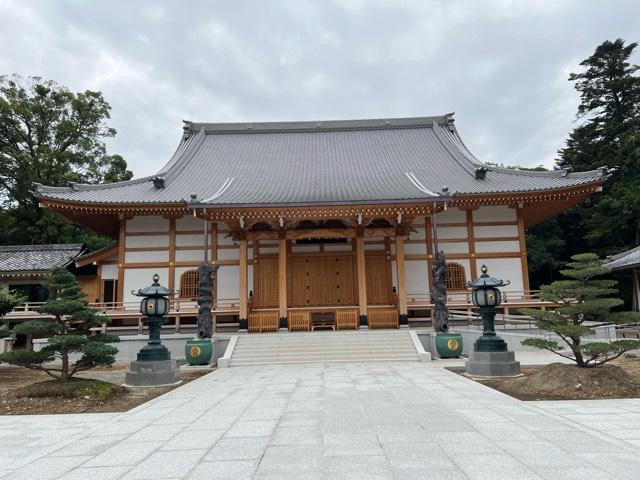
[0,75,132,243]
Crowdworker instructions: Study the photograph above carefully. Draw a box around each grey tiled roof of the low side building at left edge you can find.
[0,243,84,274]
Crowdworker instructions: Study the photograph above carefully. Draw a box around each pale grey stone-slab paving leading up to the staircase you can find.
[0,362,640,480]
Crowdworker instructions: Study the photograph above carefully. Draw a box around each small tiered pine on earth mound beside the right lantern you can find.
[521,253,640,368]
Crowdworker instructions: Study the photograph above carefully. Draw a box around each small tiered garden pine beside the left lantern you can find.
[0,268,119,381]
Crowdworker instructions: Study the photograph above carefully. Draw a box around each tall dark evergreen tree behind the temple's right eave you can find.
[527,39,640,292]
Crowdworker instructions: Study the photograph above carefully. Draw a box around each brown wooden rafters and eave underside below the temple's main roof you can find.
[40,180,604,232]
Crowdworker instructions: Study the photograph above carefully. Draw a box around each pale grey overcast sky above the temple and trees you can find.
[0,0,640,176]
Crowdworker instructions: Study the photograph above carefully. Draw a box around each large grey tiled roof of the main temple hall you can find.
[35,114,605,206]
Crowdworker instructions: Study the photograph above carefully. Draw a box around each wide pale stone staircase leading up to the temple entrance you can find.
[229,330,419,367]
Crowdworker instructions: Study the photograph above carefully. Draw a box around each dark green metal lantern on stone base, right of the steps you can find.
[465,265,520,377]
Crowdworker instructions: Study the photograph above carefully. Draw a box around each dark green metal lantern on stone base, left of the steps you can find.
[126,273,180,387]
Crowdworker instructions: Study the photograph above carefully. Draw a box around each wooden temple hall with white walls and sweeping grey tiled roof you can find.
[34,114,606,331]
